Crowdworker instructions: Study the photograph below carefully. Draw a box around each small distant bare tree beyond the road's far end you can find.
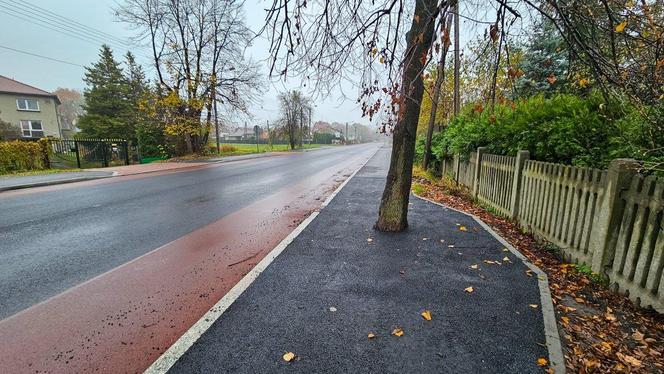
[279,90,312,149]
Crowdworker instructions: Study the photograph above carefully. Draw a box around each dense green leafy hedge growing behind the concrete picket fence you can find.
[416,94,656,168]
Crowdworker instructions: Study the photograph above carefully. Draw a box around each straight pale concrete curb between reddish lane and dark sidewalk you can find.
[144,146,382,374]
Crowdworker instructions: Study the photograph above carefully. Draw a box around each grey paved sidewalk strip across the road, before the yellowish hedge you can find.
[0,170,113,192]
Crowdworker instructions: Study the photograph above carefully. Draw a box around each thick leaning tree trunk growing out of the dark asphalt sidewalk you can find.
[375,0,438,231]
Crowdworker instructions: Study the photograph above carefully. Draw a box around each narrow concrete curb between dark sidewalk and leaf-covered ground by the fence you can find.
[413,193,565,374]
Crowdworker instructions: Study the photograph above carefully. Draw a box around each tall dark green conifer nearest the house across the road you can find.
[78,45,135,139]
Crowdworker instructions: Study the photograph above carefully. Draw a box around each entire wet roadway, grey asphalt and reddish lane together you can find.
[0,144,378,372]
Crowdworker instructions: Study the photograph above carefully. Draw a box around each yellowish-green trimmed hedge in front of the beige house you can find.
[0,139,50,174]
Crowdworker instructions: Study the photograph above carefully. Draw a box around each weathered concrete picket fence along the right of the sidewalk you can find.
[442,148,664,312]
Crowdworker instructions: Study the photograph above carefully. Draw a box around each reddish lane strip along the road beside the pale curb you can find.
[0,147,371,373]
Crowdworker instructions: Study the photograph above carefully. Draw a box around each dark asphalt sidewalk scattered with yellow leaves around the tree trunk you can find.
[158,148,557,373]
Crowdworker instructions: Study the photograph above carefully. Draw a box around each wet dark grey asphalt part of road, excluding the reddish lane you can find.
[0,144,377,320]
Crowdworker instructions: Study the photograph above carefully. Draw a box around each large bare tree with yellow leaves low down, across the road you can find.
[117,0,259,151]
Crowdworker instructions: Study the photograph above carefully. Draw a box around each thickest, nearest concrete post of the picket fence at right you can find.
[589,158,639,274]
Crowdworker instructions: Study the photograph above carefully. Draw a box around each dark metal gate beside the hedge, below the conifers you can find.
[49,139,129,169]
